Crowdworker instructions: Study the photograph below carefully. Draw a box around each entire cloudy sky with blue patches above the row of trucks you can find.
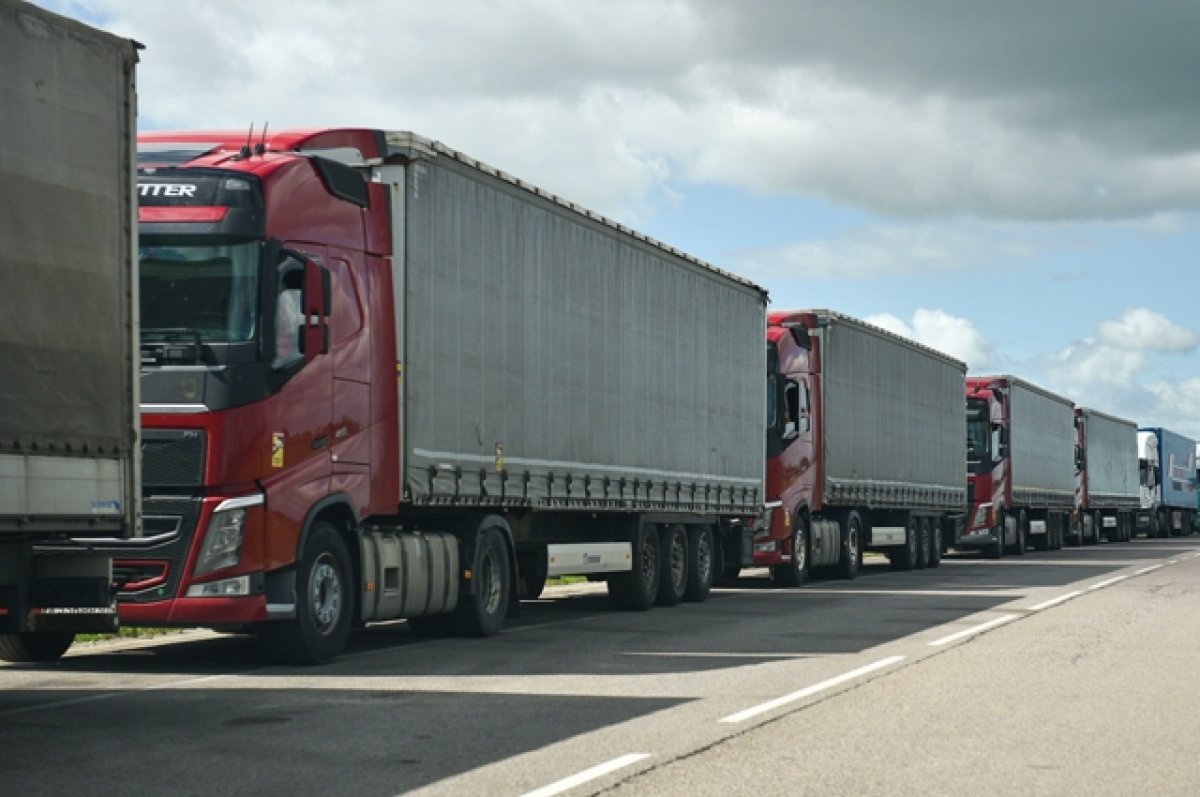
[38,0,1200,438]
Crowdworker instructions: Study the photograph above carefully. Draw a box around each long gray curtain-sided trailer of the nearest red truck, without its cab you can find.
[372,132,767,609]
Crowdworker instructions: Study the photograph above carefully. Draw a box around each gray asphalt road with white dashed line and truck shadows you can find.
[0,537,1200,797]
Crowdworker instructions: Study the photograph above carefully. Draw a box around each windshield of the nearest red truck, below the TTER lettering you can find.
[138,241,262,343]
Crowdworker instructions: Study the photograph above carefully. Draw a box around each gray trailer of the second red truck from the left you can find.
[816,312,966,569]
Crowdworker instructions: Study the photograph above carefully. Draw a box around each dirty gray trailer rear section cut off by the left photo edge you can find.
[0,0,140,661]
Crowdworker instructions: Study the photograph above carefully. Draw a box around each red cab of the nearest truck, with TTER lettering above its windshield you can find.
[114,130,400,648]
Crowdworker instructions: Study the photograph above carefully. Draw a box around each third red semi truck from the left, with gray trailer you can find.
[955,376,1075,558]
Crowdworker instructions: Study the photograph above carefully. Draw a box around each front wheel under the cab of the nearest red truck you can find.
[259,520,354,664]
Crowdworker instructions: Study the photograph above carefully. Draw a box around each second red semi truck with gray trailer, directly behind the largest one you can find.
[725,310,966,586]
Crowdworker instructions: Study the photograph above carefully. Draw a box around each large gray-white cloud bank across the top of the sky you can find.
[43,0,1200,222]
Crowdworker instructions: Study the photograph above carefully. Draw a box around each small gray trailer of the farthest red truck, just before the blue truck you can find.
[1075,407,1141,544]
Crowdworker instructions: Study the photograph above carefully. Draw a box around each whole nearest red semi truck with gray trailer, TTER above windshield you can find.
[98,128,767,663]
